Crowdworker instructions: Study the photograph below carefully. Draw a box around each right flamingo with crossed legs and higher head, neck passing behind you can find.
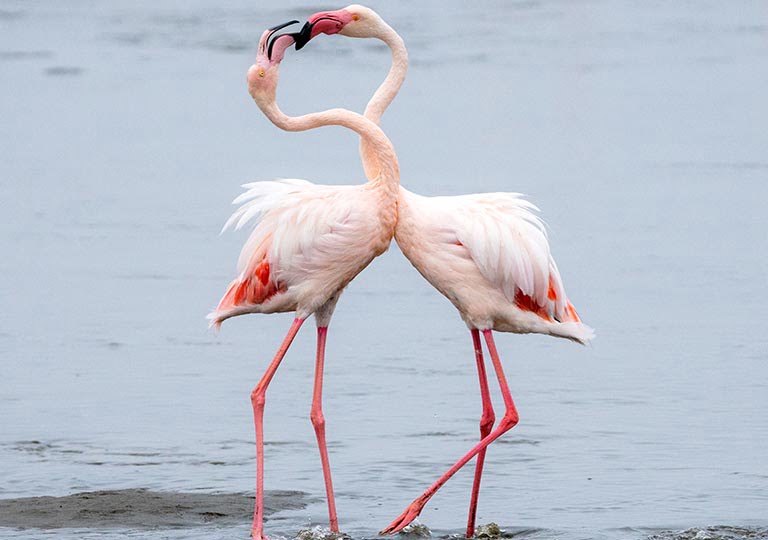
[284,4,594,538]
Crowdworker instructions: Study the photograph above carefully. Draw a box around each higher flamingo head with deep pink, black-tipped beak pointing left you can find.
[296,4,383,50]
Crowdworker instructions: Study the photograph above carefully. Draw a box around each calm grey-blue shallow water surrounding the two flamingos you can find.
[0,0,768,540]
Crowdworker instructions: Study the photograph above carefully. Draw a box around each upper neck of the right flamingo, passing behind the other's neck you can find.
[360,21,408,178]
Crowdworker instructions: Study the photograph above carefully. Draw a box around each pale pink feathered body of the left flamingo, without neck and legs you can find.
[208,180,397,327]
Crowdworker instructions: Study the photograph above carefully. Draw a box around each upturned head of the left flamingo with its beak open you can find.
[247,21,299,106]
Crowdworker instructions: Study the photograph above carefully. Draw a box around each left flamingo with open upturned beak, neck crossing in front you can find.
[208,21,400,540]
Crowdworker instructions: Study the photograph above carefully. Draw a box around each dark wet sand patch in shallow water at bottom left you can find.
[0,489,307,529]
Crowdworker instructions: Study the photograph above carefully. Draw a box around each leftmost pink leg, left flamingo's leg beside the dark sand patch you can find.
[251,319,304,540]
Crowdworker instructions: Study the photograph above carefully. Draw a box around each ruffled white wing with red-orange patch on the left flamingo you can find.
[212,179,371,321]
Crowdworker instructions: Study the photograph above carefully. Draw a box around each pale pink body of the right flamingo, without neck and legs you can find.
[395,187,593,343]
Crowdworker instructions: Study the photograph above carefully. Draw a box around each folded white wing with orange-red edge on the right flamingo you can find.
[442,193,578,322]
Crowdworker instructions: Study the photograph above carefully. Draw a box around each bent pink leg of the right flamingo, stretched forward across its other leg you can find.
[381,330,518,534]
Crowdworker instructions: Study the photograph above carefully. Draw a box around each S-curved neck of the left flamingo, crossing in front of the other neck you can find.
[261,100,400,194]
